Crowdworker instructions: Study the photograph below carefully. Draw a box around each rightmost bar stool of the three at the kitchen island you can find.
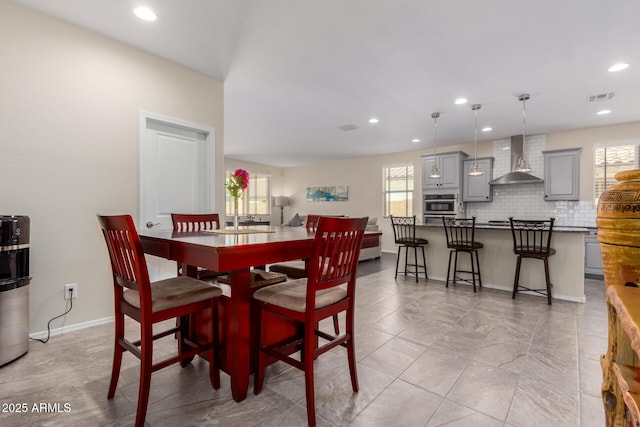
[509,218,556,305]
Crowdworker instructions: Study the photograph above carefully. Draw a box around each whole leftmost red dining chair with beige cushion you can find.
[98,215,222,426]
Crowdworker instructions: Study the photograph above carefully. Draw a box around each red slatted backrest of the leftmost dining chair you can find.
[98,215,151,309]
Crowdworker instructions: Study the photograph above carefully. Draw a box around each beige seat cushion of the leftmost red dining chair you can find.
[123,276,222,313]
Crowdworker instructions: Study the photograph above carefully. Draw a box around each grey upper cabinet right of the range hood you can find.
[542,148,582,200]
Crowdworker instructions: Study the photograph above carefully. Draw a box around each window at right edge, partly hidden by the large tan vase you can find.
[593,142,640,204]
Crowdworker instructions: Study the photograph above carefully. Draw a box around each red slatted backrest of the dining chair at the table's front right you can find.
[307,217,368,298]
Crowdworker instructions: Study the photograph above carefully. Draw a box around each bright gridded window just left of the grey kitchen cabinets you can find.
[382,165,413,216]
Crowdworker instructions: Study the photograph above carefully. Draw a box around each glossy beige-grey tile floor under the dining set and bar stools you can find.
[0,254,607,427]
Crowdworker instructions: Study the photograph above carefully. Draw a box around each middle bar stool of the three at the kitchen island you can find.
[442,216,484,292]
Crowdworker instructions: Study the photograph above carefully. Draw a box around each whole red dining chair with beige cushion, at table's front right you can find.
[253,217,367,426]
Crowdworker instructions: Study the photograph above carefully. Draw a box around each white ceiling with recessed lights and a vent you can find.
[14,0,640,166]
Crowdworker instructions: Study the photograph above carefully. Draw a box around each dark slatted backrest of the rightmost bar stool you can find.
[509,218,555,256]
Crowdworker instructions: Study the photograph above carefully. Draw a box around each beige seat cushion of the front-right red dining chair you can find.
[253,279,347,313]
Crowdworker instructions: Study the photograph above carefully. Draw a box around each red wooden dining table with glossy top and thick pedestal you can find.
[140,226,314,402]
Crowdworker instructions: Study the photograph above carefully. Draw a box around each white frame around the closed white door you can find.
[138,111,216,229]
